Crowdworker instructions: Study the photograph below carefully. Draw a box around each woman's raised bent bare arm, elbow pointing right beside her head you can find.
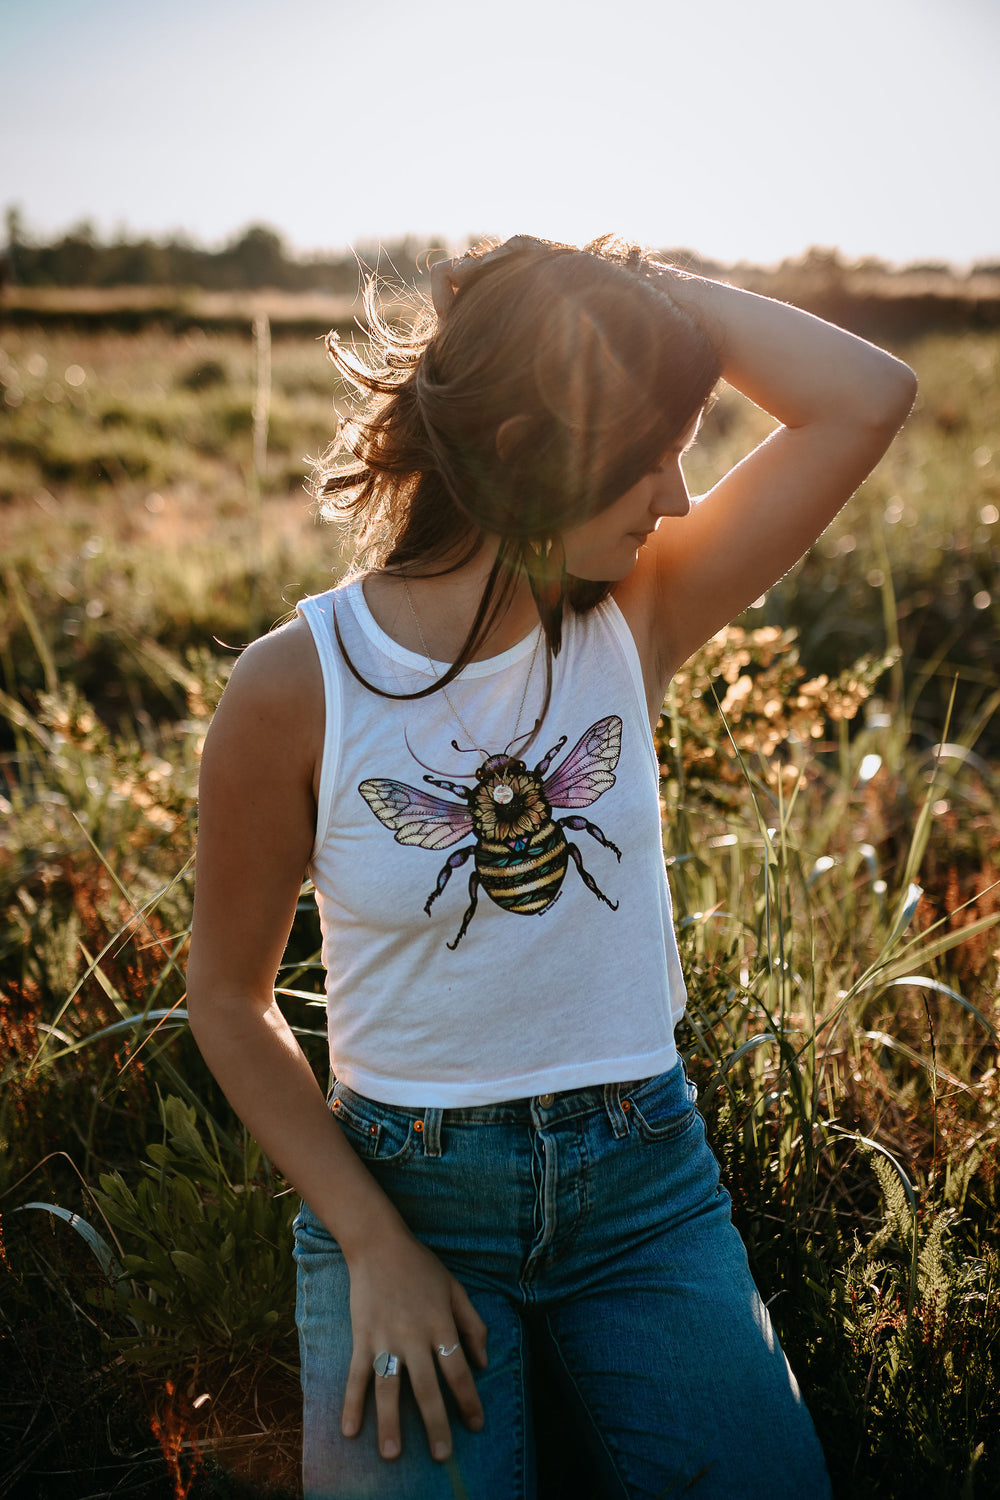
[621,267,916,690]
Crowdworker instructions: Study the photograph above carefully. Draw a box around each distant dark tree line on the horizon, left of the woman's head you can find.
[3,209,445,294]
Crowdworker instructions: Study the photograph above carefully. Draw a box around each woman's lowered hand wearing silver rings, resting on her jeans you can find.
[342,1226,486,1460]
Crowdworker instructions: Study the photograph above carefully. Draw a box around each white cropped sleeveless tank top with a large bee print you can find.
[298,579,685,1109]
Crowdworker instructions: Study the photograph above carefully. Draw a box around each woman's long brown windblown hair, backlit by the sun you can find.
[313,236,720,701]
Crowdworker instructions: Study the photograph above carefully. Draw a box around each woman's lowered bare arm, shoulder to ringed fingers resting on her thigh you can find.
[187,621,486,1458]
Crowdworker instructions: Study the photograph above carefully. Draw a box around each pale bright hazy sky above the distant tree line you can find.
[0,0,1000,267]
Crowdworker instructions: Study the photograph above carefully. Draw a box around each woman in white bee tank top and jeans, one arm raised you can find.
[189,237,915,1500]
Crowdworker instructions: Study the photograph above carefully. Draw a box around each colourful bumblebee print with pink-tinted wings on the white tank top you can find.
[358,716,622,951]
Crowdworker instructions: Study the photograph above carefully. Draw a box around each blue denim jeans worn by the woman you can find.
[295,1064,829,1500]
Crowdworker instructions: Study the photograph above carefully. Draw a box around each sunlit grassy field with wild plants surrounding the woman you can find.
[0,283,1000,1500]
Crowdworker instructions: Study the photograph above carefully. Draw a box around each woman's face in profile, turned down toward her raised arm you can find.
[562,414,700,582]
